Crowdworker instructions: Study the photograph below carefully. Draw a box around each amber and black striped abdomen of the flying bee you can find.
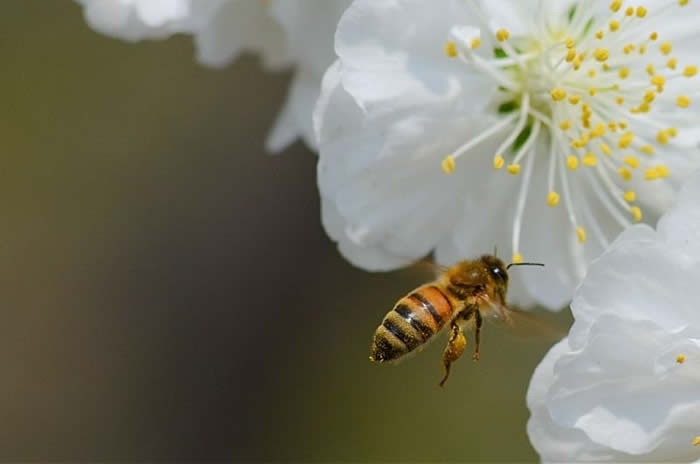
[370,285,454,362]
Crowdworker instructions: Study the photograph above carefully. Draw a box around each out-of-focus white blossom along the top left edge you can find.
[76,0,350,152]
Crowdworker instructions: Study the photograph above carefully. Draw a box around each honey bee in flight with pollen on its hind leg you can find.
[369,255,544,387]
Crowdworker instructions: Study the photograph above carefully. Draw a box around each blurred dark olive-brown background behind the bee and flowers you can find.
[0,0,569,462]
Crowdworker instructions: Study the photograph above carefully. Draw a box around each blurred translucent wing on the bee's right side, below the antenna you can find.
[496,306,567,341]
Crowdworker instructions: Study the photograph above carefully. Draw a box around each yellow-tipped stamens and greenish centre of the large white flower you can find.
[442,0,698,262]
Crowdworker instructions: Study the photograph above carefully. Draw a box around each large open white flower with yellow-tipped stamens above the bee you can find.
[315,0,700,308]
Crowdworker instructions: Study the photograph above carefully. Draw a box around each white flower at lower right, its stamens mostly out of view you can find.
[527,174,700,462]
